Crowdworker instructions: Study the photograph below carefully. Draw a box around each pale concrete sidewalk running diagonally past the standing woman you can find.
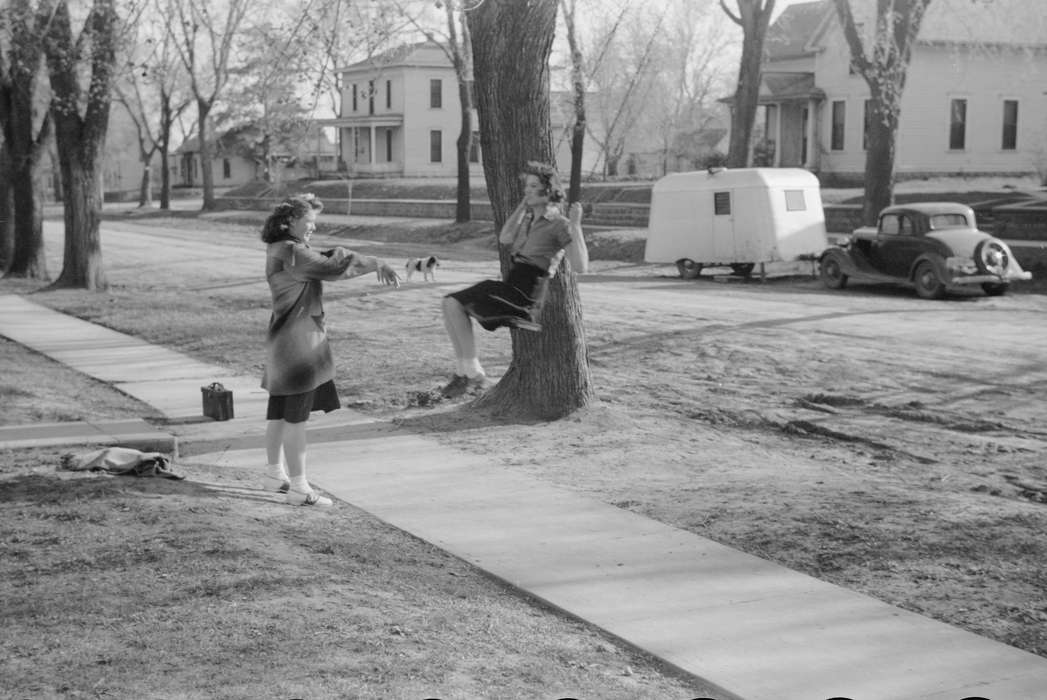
[0,296,1047,700]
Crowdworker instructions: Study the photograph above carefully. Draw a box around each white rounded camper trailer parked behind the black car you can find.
[644,167,828,278]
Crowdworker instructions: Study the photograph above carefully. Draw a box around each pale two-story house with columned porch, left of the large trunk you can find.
[322,42,482,177]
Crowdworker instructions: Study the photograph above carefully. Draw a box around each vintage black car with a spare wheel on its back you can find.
[819,202,1031,299]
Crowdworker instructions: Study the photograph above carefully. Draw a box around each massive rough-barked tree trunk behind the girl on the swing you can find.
[469,0,594,420]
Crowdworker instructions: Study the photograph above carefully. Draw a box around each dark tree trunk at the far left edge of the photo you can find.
[0,0,52,279]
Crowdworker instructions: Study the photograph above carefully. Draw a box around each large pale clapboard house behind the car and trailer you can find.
[760,0,1047,183]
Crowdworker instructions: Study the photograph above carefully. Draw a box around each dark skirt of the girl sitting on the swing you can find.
[447,263,549,331]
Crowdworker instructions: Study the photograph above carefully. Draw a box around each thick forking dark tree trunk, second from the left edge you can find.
[41,0,119,290]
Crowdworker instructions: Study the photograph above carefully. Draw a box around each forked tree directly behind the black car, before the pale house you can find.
[833,0,931,224]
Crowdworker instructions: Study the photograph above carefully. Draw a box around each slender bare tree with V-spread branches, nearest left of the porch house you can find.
[165,0,251,210]
